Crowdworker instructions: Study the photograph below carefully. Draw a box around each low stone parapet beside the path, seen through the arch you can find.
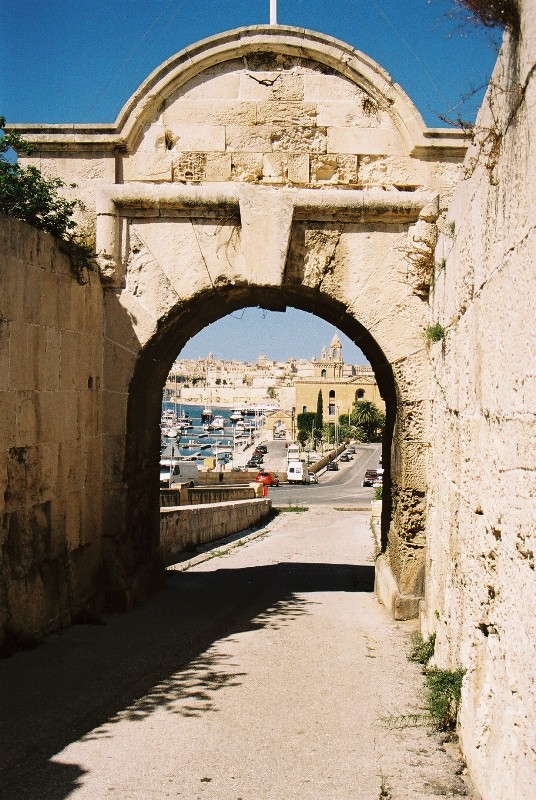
[160,498,272,564]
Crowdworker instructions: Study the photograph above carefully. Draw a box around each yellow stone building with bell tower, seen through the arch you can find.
[294,336,385,422]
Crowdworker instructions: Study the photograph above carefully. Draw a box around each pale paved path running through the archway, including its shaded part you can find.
[0,506,472,800]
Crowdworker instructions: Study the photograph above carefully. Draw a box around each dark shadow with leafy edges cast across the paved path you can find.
[0,562,374,800]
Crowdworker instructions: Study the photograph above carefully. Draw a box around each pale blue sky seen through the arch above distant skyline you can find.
[177,308,368,364]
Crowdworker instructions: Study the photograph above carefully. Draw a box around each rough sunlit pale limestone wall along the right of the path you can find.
[424,9,536,800]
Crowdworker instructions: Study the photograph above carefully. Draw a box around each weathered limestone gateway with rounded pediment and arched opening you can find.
[18,26,466,613]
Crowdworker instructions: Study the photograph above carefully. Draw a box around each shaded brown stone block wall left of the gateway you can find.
[0,212,102,641]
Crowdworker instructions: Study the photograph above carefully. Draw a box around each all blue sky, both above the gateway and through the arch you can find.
[0,0,500,363]
